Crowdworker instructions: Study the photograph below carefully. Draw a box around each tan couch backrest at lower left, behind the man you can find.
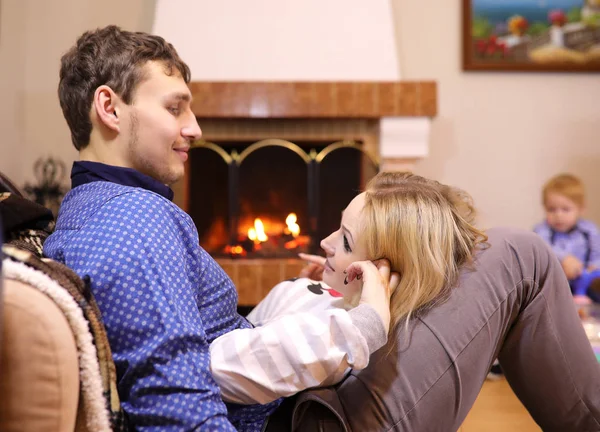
[0,279,79,432]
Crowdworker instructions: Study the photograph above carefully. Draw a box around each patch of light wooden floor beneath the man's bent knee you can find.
[459,379,541,432]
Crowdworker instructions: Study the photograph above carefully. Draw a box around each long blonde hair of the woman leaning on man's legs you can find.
[362,172,487,328]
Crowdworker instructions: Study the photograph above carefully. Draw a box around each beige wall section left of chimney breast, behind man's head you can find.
[0,0,154,189]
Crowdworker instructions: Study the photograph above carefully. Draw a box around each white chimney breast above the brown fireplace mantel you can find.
[153,0,399,81]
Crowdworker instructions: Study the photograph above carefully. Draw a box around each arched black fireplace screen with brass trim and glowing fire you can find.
[188,139,378,258]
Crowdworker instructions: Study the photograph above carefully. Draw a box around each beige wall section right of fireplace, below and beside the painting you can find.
[392,0,600,228]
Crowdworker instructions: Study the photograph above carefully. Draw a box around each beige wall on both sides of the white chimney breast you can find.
[0,0,600,228]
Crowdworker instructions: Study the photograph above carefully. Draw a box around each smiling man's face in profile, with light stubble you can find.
[122,61,202,185]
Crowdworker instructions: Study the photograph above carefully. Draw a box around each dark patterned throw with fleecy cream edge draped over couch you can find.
[0,193,128,432]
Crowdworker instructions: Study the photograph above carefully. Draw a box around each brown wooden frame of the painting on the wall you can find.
[462,0,600,73]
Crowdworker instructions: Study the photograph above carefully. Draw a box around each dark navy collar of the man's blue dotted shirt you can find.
[71,161,173,201]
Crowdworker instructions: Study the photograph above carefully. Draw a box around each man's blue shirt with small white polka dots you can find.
[44,163,280,431]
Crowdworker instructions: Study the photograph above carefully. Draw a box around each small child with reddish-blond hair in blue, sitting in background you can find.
[534,174,600,303]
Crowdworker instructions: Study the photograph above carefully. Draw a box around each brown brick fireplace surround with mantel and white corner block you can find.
[173,81,437,306]
